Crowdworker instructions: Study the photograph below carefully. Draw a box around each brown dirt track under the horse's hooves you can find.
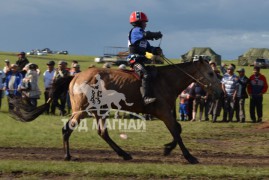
[0,147,269,167]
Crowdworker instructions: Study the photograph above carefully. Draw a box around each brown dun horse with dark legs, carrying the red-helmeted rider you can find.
[9,60,221,163]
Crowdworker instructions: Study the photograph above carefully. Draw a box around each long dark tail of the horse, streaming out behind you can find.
[9,76,73,122]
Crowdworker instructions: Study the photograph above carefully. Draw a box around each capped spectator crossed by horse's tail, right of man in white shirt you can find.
[51,61,69,116]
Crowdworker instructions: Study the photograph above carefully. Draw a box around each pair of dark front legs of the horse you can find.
[164,116,199,164]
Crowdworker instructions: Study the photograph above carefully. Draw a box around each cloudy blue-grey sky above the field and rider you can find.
[0,0,269,60]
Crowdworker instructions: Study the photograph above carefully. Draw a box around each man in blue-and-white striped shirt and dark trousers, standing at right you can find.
[221,65,238,122]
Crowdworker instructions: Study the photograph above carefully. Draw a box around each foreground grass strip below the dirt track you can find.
[0,160,269,179]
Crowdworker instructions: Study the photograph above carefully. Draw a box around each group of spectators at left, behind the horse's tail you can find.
[0,52,80,116]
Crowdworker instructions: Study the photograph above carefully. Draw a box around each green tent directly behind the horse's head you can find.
[181,47,221,65]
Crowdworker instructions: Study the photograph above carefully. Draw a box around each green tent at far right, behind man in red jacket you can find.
[238,48,269,66]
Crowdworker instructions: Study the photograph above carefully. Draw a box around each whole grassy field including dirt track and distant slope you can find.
[0,53,269,179]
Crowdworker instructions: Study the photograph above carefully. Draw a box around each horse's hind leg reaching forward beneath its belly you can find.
[97,119,132,160]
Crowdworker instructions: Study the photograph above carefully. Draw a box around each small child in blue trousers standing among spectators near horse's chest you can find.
[178,89,190,121]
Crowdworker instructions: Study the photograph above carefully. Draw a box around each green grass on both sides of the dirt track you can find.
[0,114,269,179]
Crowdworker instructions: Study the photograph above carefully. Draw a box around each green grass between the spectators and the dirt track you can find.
[0,114,269,155]
